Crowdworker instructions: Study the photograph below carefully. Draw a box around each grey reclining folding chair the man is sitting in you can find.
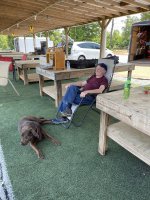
[56,59,115,128]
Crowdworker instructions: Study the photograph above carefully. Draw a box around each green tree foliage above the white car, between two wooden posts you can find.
[69,22,100,43]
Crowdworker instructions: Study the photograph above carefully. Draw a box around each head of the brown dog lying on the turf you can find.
[21,126,42,145]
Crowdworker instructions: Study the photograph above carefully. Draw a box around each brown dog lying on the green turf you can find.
[18,116,60,159]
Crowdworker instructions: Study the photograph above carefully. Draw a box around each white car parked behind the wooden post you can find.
[68,42,113,60]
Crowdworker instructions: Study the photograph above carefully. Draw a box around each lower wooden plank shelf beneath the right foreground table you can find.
[107,122,150,165]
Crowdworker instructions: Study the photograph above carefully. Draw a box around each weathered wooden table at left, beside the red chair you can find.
[15,60,40,85]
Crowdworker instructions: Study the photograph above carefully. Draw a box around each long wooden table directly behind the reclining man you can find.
[36,63,135,106]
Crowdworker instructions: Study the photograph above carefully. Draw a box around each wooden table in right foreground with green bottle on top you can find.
[96,87,150,165]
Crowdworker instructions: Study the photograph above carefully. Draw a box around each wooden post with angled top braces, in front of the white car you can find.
[99,19,111,58]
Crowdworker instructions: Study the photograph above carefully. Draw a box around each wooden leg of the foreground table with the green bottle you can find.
[98,111,109,155]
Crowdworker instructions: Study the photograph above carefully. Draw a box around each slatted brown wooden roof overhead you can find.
[0,0,150,36]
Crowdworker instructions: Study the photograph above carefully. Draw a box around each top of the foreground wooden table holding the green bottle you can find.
[96,87,150,135]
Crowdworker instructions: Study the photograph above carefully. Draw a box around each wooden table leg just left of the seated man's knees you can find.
[54,80,62,107]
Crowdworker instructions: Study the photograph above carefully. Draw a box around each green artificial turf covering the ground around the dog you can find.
[0,77,150,200]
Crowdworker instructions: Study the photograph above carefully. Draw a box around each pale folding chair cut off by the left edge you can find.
[0,61,20,96]
